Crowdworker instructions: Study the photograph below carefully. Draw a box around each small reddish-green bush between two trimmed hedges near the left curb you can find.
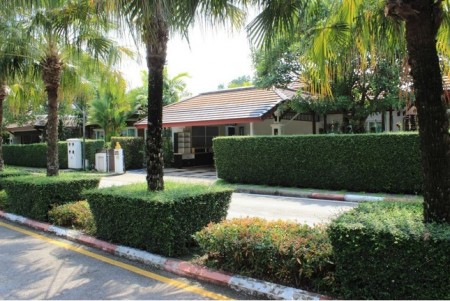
[48,201,95,235]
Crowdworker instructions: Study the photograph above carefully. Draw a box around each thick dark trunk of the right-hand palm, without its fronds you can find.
[400,0,450,223]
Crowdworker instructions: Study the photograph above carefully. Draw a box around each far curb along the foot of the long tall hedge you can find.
[235,187,386,203]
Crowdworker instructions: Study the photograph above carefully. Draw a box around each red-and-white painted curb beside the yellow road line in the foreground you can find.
[0,210,331,300]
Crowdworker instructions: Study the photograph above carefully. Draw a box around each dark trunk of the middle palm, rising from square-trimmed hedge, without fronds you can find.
[145,13,169,191]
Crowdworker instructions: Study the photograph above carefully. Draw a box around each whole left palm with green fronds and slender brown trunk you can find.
[12,0,122,176]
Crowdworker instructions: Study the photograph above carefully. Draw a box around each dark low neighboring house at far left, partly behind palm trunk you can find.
[6,115,81,144]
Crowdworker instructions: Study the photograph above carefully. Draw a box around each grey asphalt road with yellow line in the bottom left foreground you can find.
[0,220,249,300]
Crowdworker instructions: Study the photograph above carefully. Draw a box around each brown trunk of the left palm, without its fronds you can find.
[42,51,62,176]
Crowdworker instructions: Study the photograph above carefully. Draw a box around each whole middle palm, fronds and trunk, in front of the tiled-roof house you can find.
[105,0,244,191]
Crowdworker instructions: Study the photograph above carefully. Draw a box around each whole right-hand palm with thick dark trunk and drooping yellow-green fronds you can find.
[249,0,450,223]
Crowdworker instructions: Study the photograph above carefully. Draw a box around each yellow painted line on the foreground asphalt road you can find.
[0,222,231,300]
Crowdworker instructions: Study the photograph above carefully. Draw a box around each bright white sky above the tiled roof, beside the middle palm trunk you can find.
[121,12,254,95]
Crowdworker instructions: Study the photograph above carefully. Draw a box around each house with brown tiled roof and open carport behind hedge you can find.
[135,87,362,166]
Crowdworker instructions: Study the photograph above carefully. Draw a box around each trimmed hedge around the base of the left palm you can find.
[3,173,100,222]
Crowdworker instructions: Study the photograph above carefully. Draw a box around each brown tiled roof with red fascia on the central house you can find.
[135,87,292,128]
